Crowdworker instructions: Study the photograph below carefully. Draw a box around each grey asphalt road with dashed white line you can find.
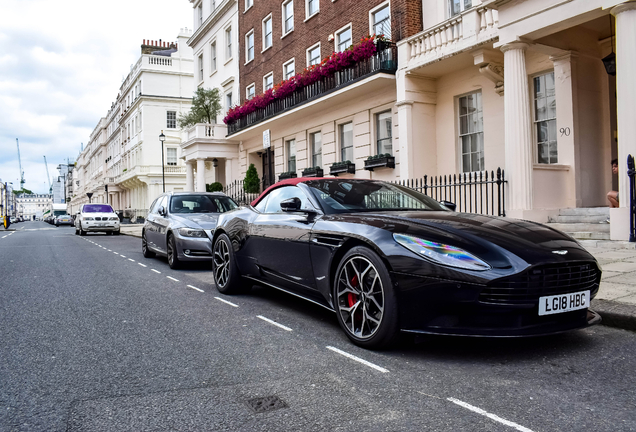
[0,222,636,431]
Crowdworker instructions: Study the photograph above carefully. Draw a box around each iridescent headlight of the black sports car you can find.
[393,234,490,270]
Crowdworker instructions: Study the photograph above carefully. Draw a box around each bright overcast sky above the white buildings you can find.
[0,0,193,193]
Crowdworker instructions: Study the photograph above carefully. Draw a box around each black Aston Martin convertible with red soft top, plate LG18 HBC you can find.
[212,178,601,348]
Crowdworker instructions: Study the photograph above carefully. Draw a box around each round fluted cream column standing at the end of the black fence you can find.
[501,42,533,217]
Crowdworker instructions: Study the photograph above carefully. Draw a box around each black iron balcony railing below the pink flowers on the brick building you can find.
[227,42,397,135]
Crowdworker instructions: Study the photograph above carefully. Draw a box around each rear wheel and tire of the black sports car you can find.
[212,233,252,295]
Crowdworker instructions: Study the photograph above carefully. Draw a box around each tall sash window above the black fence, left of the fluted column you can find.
[459,92,484,172]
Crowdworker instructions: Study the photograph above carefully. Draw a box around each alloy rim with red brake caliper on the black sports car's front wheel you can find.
[336,256,384,339]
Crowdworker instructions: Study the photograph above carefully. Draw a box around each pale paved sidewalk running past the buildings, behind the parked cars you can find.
[115,228,636,331]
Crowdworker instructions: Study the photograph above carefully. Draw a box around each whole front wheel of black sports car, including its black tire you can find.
[333,246,399,349]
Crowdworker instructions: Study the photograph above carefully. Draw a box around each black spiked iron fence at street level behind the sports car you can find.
[394,168,507,216]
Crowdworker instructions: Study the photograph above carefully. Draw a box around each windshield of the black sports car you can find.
[305,179,448,213]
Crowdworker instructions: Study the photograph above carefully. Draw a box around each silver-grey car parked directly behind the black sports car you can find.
[141,192,238,268]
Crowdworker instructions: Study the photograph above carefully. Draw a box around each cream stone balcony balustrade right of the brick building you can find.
[400,7,499,72]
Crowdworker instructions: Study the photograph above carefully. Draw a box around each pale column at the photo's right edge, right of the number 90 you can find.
[610,1,636,240]
